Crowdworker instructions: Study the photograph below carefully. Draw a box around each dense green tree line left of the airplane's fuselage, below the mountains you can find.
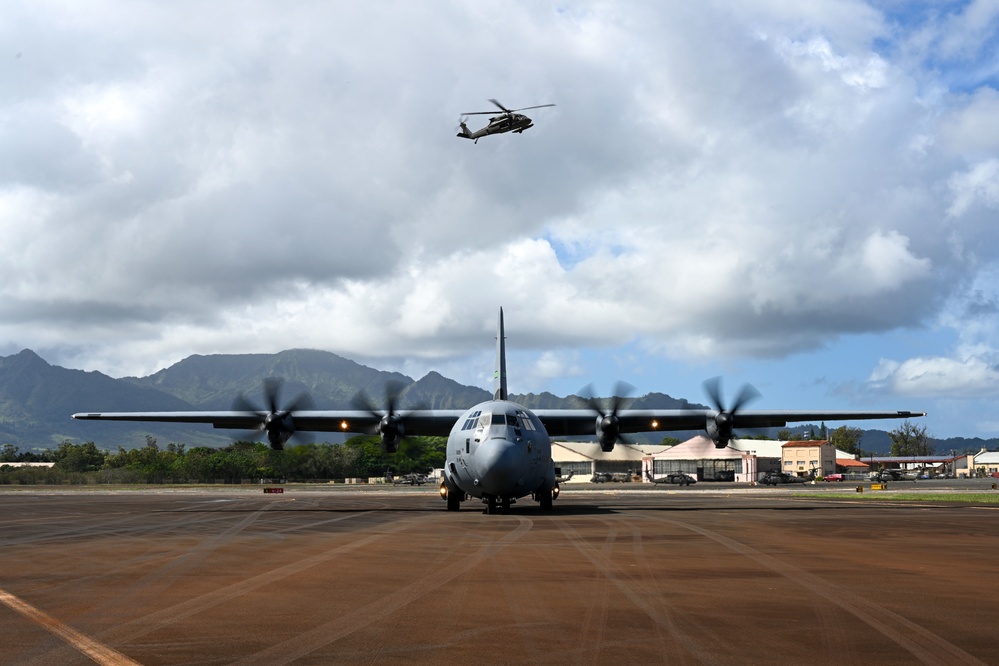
[0,436,447,484]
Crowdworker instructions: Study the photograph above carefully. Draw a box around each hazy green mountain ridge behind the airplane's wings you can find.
[0,349,999,452]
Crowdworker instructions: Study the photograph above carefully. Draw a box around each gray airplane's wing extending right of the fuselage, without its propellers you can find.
[534,409,926,437]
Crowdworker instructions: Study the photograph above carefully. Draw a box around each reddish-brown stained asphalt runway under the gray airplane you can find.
[0,486,999,665]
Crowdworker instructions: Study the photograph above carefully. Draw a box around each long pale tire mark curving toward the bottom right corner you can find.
[648,516,985,666]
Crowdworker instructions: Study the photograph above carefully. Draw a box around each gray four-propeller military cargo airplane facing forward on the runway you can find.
[73,308,926,514]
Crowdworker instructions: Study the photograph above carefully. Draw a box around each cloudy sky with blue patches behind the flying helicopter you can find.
[0,0,999,438]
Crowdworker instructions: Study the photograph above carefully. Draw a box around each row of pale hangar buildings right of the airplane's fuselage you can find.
[552,436,869,483]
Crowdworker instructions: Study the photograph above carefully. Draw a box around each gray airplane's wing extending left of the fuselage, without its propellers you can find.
[73,409,464,437]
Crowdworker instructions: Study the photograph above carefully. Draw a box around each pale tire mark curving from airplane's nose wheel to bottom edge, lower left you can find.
[238,516,534,664]
